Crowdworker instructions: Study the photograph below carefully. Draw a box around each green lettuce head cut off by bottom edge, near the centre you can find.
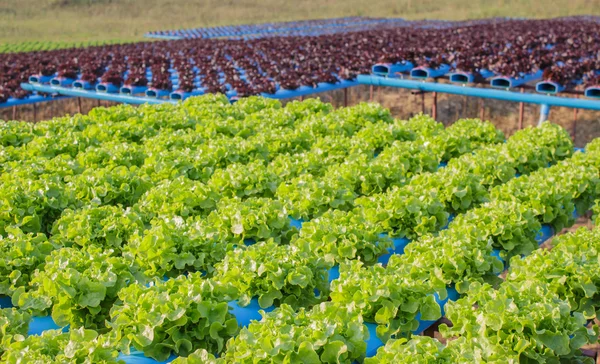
[223,302,369,364]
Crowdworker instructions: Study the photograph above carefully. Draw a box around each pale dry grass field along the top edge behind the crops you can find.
[0,0,600,44]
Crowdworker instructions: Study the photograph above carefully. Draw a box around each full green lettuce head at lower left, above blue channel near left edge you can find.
[12,246,141,331]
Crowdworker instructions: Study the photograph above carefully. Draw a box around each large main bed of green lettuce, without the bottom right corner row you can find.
[0,95,600,363]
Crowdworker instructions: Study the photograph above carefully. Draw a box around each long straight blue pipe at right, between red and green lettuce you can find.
[357,75,600,110]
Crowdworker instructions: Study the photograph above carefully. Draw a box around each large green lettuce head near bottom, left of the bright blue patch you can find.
[108,273,238,361]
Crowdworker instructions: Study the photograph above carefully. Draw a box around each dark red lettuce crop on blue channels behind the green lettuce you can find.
[0,18,600,102]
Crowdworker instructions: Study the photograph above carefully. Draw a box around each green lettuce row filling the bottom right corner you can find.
[365,223,600,364]
